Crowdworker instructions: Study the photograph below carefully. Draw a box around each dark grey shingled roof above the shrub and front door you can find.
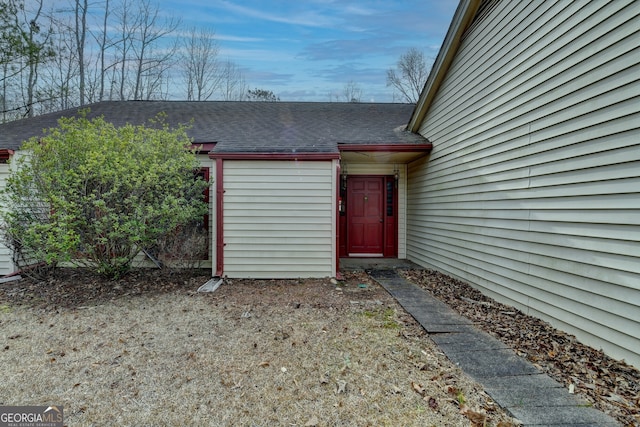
[0,101,427,153]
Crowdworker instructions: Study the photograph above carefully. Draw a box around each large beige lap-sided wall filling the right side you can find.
[407,0,640,366]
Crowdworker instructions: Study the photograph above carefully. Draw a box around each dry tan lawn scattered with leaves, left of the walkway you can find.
[0,274,508,426]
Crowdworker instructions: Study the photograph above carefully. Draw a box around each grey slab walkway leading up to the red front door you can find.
[342,260,620,427]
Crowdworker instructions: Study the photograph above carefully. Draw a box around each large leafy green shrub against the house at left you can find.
[2,113,207,278]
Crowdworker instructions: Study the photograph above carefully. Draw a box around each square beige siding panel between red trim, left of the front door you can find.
[223,160,337,278]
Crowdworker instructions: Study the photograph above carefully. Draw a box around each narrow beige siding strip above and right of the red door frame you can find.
[346,163,407,259]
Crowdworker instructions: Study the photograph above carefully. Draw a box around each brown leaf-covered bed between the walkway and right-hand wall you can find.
[402,270,640,426]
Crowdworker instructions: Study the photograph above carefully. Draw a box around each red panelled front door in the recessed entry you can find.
[347,176,385,256]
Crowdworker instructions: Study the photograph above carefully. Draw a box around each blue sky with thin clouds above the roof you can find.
[159,0,458,102]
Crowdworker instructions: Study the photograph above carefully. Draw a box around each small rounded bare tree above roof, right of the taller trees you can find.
[182,27,222,101]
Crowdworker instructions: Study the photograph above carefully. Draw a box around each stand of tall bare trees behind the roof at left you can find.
[0,0,277,121]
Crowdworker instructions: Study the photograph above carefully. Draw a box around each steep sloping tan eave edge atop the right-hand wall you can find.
[407,0,482,133]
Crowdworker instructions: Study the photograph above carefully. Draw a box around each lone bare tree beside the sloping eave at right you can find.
[387,47,429,104]
